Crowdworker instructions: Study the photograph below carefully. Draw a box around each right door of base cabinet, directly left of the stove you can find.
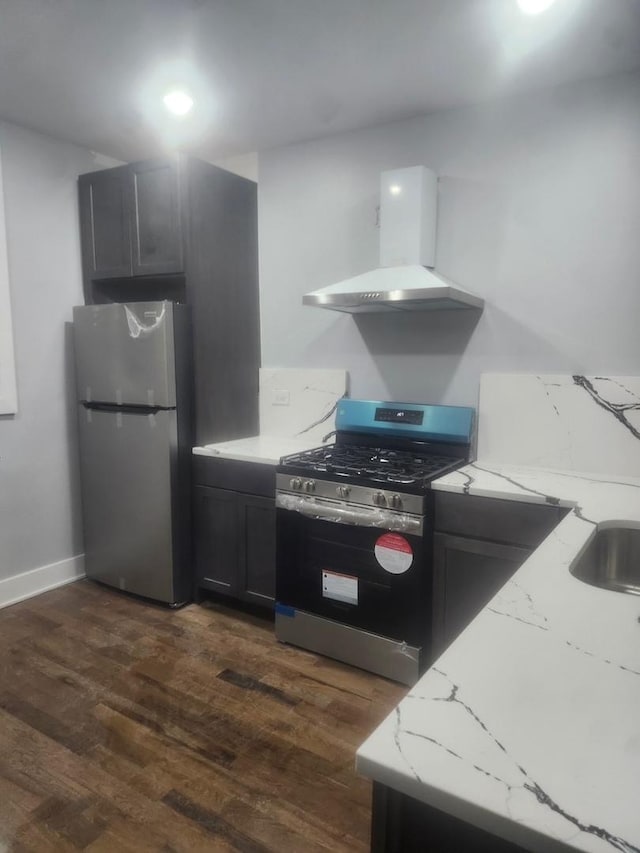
[238,495,276,605]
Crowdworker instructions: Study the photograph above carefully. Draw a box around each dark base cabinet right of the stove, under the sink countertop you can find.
[433,493,566,658]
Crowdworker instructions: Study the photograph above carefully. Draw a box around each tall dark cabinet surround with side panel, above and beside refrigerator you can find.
[79,155,260,444]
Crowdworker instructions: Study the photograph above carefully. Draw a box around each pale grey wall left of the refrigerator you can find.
[0,122,115,584]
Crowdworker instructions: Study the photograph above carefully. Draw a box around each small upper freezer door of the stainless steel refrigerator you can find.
[73,302,181,407]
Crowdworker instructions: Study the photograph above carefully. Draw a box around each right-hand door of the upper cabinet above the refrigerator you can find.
[129,158,184,275]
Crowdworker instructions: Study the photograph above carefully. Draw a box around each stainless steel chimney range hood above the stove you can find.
[302,166,484,314]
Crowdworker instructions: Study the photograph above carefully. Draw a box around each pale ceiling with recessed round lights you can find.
[0,0,640,160]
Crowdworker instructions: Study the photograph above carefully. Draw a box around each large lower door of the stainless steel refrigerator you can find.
[79,406,178,604]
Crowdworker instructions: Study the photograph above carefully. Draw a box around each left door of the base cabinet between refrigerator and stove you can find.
[194,486,241,595]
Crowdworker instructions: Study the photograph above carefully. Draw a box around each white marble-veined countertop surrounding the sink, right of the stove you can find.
[357,463,640,853]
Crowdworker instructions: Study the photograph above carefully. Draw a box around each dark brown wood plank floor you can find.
[0,581,406,853]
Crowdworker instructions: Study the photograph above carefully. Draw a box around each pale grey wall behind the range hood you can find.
[259,68,640,405]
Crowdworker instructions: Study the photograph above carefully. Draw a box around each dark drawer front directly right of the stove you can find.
[434,492,568,548]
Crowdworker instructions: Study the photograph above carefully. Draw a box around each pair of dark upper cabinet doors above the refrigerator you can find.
[79,157,184,280]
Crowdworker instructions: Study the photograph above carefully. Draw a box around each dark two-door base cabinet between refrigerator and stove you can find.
[194,459,276,607]
